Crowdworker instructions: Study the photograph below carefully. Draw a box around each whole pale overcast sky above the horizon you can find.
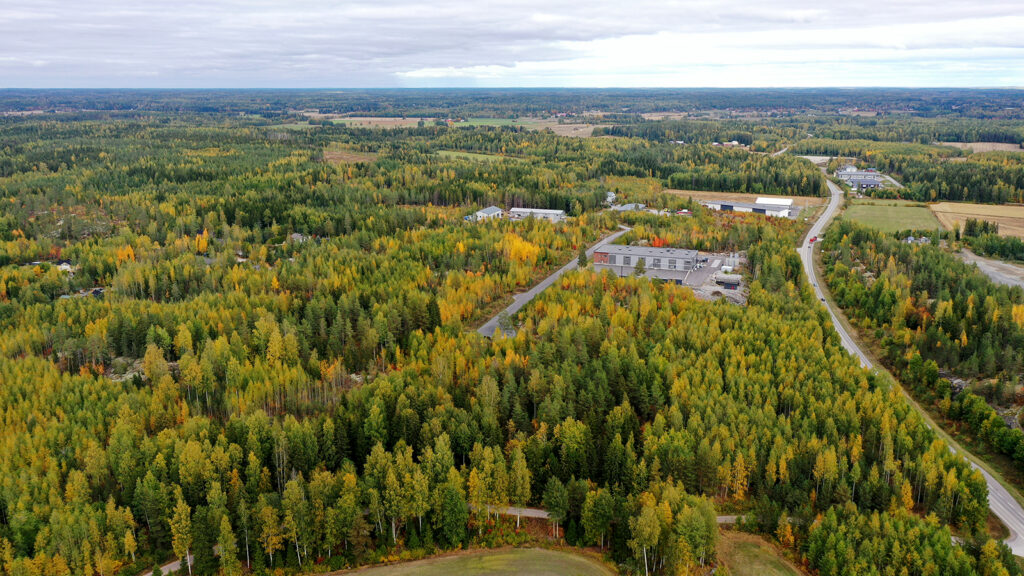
[0,0,1024,88]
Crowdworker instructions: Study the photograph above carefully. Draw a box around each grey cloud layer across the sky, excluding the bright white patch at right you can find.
[0,0,1024,87]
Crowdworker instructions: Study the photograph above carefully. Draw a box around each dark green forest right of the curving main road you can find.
[822,220,1024,487]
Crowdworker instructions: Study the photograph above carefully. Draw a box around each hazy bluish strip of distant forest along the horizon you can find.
[6,88,1021,120]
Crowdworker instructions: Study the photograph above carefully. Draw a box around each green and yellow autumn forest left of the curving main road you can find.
[0,103,1022,576]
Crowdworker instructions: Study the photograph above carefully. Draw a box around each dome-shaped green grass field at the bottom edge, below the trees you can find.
[344,548,615,576]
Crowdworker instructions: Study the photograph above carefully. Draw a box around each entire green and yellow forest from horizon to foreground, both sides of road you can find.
[0,89,1024,576]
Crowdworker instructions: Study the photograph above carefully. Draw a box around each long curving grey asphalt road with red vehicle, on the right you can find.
[798,174,1024,556]
